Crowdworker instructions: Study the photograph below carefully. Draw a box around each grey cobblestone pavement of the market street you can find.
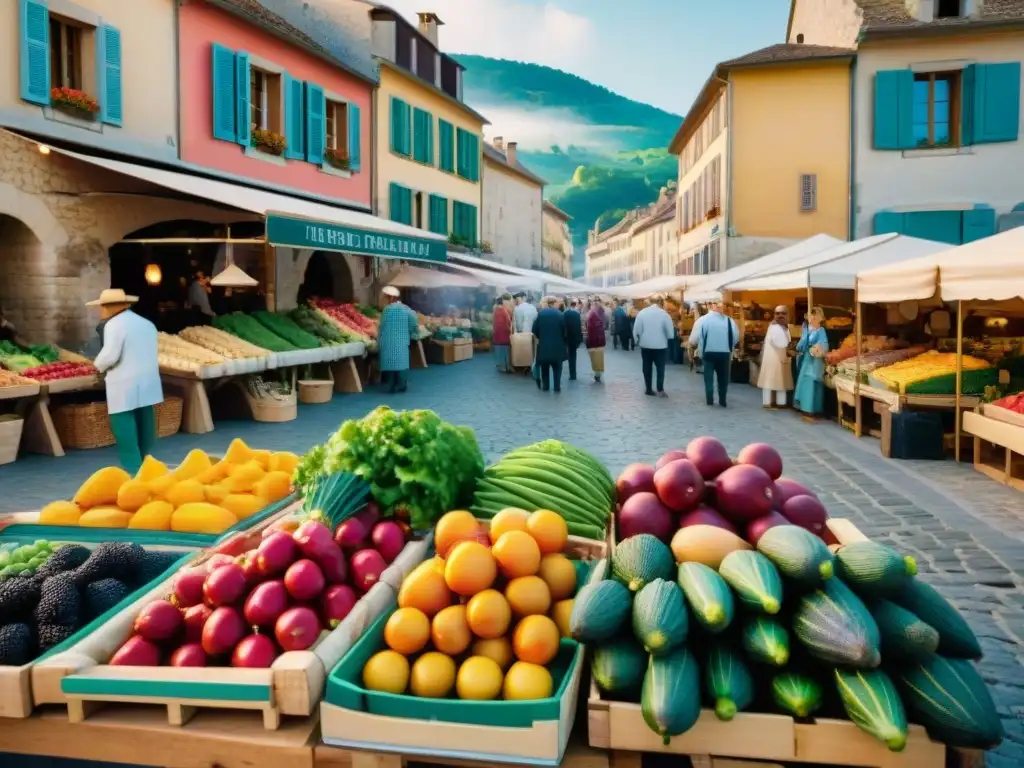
[0,350,1024,768]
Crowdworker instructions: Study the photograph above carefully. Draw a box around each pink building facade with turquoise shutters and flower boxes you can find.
[178,0,375,209]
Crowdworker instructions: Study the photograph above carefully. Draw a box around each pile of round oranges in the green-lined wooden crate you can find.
[362,509,577,700]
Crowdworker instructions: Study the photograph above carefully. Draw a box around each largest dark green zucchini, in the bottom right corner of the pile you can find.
[890,655,1005,750]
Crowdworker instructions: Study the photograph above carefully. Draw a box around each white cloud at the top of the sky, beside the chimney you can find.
[384,0,596,72]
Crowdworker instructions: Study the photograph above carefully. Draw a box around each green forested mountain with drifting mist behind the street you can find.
[455,54,682,264]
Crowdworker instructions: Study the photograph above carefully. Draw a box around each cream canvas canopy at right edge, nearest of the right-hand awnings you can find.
[857,227,1024,304]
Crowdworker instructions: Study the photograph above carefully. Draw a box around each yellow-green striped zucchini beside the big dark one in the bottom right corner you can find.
[835,670,907,752]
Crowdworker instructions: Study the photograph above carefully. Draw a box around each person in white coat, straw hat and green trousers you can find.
[86,288,164,474]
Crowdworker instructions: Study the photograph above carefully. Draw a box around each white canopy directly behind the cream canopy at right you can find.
[725,233,947,291]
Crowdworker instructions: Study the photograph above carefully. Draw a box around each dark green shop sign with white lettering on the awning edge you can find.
[266,213,447,263]
